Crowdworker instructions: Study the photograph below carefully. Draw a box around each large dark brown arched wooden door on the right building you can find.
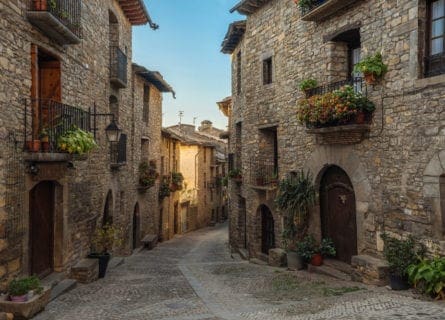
[320,166,357,263]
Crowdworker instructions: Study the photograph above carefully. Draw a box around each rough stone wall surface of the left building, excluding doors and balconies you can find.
[0,0,166,290]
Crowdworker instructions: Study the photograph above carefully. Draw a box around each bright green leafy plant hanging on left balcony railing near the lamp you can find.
[57,128,97,155]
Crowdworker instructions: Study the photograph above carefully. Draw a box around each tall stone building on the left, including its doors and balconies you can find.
[0,0,170,290]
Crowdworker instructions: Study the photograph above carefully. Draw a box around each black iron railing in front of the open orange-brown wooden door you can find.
[24,99,91,152]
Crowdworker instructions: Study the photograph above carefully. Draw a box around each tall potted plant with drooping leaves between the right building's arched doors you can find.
[275,171,315,270]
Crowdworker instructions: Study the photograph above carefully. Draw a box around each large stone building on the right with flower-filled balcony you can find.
[222,0,445,280]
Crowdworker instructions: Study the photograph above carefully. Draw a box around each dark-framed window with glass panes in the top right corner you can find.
[425,0,445,77]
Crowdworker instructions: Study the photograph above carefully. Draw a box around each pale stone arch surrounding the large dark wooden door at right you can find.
[303,146,377,254]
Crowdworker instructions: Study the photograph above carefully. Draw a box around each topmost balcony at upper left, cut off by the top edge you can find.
[27,0,81,45]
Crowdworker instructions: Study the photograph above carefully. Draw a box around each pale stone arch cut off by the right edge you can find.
[423,150,445,239]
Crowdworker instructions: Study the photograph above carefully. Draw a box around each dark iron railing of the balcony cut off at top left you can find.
[29,0,82,38]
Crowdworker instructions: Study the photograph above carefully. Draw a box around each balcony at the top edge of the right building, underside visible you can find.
[301,0,357,21]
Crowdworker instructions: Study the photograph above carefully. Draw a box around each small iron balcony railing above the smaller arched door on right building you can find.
[250,160,278,187]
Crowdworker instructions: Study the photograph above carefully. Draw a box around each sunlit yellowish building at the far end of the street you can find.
[164,122,227,233]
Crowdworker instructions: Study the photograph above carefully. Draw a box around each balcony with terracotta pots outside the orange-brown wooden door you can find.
[24,99,91,162]
